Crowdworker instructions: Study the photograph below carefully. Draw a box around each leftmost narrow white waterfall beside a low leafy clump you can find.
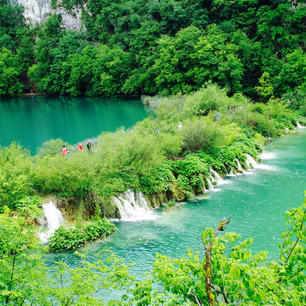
[39,201,64,243]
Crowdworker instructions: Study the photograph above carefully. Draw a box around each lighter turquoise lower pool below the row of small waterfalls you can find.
[74,129,306,284]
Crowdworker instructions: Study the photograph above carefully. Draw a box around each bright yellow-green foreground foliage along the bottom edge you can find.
[0,195,306,306]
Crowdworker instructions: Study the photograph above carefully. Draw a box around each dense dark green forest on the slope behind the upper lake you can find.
[0,0,306,104]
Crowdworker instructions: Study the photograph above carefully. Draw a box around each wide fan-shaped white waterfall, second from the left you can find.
[114,190,157,221]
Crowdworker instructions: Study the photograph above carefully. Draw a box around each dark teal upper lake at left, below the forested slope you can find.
[0,97,148,153]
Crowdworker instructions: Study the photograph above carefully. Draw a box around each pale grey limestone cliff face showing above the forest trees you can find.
[11,0,81,30]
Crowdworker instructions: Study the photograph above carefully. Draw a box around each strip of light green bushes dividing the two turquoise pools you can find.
[1,85,297,249]
